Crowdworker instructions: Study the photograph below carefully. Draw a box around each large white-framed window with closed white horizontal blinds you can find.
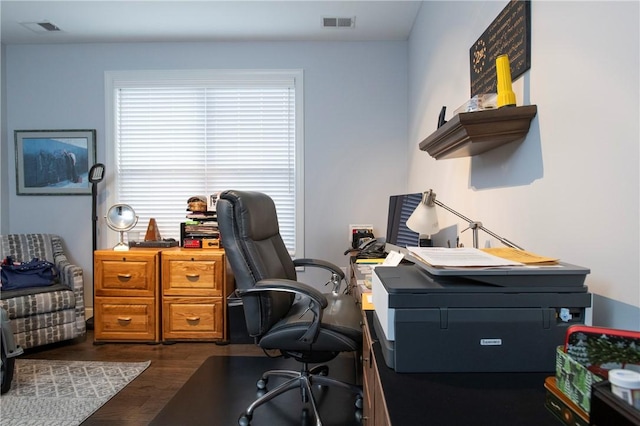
[105,70,304,256]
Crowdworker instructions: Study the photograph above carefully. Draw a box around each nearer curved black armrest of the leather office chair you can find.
[236,279,328,343]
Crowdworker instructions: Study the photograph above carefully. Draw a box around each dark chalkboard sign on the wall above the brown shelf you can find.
[469,0,531,97]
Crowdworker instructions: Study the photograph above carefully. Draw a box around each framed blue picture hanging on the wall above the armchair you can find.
[14,129,96,195]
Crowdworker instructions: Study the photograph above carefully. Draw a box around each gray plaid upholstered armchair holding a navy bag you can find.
[0,234,86,349]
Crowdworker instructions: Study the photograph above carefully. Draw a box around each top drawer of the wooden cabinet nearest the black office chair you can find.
[162,253,225,297]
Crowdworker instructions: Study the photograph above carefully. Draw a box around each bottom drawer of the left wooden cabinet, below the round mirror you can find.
[94,297,158,341]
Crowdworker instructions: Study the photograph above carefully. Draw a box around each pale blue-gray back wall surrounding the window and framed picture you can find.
[2,42,408,312]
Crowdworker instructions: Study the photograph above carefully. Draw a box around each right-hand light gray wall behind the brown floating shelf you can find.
[408,1,640,330]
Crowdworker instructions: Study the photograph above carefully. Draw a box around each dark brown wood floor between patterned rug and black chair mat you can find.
[21,331,264,426]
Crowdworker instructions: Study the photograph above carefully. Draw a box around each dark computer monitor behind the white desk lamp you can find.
[386,192,422,248]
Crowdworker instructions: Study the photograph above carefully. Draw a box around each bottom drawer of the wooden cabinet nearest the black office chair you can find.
[162,298,224,340]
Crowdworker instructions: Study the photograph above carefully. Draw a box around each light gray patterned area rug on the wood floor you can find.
[0,358,151,426]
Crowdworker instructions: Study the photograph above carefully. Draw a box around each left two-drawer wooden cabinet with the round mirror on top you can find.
[94,249,160,342]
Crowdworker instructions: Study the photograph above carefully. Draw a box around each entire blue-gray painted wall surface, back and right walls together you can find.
[0,1,640,329]
